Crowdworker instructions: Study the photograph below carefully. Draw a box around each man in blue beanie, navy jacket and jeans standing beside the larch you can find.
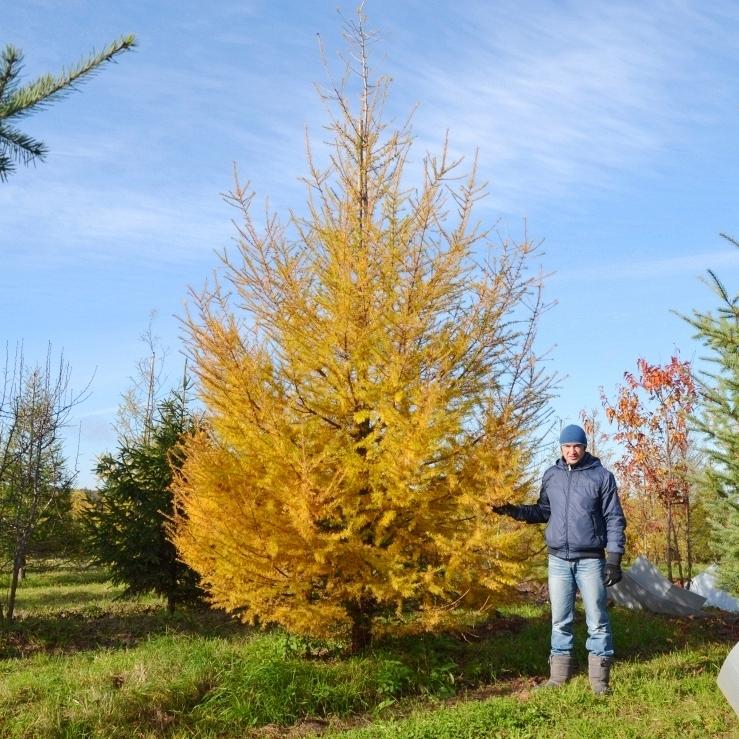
[493,425,626,694]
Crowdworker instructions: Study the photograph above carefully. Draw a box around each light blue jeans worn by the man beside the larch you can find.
[549,554,613,657]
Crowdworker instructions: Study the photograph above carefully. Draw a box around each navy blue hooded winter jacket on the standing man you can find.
[513,452,626,560]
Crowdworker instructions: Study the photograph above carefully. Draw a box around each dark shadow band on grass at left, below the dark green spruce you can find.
[0,599,249,659]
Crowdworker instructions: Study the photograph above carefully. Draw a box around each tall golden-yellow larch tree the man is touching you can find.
[172,11,551,651]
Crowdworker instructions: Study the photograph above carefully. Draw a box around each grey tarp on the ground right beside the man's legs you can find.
[608,556,706,616]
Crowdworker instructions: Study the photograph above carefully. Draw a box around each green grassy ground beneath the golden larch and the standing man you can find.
[0,568,739,739]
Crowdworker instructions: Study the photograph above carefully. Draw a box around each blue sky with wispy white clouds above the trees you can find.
[0,0,739,486]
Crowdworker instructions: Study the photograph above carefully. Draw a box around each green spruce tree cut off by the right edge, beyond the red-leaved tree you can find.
[686,236,739,594]
